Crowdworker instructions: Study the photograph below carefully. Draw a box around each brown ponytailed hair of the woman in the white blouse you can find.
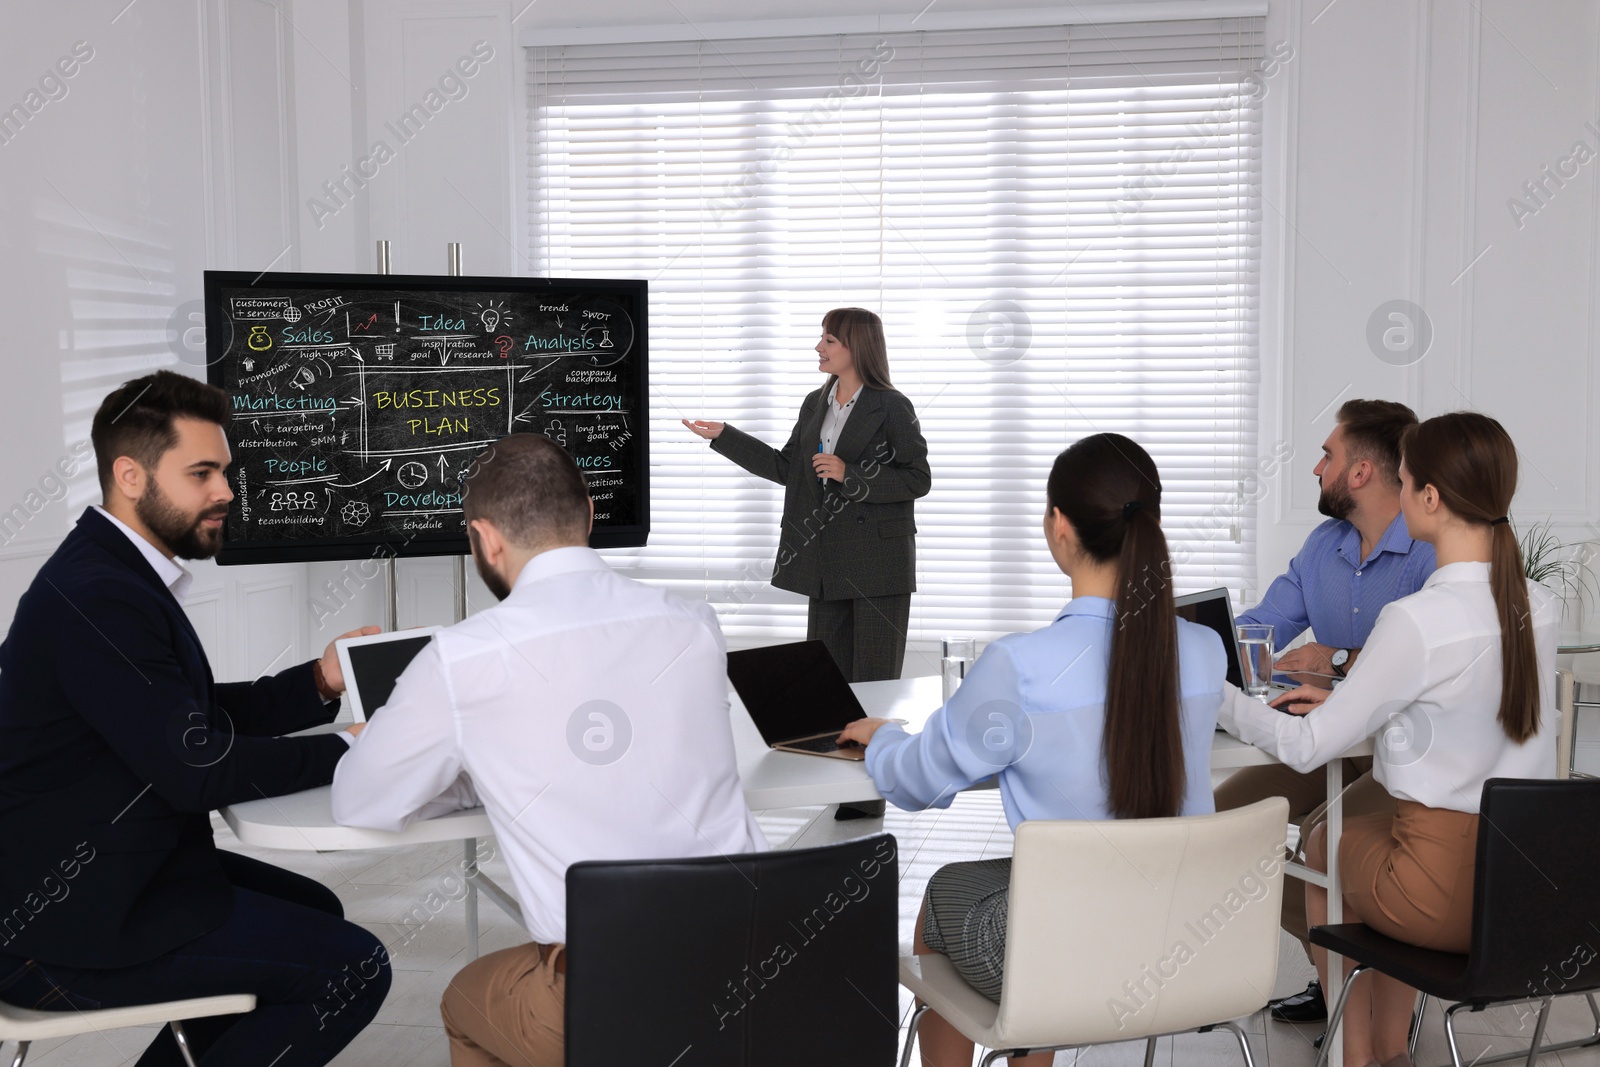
[1400,411,1539,744]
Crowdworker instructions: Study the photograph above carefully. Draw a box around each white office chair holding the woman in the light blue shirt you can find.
[899,797,1290,1067]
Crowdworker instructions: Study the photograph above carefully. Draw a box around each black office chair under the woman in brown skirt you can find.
[1310,777,1600,1067]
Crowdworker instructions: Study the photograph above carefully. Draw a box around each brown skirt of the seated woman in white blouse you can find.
[1306,800,1478,952]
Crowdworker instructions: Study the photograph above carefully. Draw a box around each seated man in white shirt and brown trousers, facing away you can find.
[333,434,766,1067]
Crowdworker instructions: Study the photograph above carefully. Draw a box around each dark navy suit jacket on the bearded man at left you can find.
[0,509,347,968]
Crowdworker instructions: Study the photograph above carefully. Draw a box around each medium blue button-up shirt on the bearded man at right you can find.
[1237,515,1435,648]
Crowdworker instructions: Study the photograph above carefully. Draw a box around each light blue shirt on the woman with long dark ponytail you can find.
[867,597,1227,830]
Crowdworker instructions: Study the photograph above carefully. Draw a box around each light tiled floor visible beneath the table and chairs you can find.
[6,790,1600,1067]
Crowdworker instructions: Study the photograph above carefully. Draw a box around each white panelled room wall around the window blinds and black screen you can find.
[0,0,1600,677]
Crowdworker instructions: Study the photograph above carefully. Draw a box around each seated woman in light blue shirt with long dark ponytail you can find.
[842,434,1227,1067]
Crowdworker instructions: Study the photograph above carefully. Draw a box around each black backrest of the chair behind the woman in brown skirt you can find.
[1467,777,1600,998]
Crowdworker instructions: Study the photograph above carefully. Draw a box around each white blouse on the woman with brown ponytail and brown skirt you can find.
[1218,563,1558,814]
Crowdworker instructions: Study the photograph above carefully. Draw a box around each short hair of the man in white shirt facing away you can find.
[461,434,589,549]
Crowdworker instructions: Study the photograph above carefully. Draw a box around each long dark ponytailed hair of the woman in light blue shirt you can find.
[1048,434,1187,819]
